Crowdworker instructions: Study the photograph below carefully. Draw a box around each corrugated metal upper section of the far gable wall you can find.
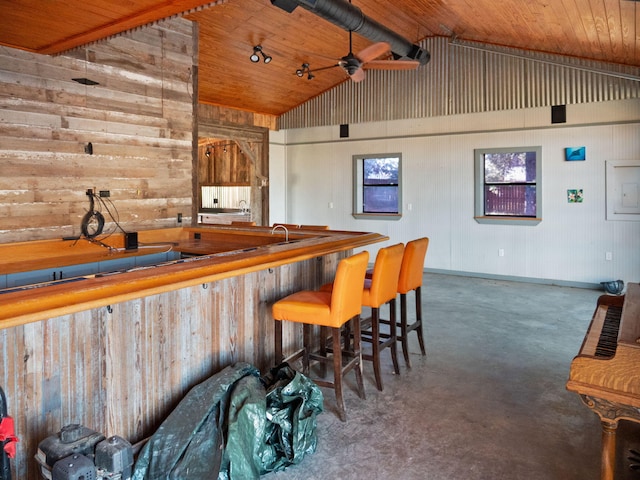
[278,38,640,129]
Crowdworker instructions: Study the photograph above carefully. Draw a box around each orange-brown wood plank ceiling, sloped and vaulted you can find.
[0,0,640,115]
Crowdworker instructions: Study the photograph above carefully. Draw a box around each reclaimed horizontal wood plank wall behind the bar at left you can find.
[0,19,197,243]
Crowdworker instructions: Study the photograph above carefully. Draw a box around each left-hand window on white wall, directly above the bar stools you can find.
[353,153,402,219]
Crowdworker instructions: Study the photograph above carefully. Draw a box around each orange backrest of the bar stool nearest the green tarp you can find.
[331,251,369,326]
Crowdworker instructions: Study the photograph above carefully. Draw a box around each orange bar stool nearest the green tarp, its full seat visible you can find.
[272,252,369,422]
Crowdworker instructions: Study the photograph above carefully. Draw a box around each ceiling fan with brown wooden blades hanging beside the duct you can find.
[306,31,420,82]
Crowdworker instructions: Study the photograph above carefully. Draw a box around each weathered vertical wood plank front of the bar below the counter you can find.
[0,252,347,480]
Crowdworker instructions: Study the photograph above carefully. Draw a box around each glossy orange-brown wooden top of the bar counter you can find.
[0,226,388,329]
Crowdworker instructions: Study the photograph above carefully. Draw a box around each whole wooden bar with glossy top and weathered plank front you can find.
[0,226,387,480]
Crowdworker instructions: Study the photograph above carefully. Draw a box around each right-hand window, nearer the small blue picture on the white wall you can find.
[475,147,542,225]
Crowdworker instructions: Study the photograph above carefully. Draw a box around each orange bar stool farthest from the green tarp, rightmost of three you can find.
[391,237,429,367]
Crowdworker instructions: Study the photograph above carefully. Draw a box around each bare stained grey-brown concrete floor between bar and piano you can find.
[263,274,628,480]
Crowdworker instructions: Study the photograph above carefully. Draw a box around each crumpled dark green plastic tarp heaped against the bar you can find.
[132,363,324,480]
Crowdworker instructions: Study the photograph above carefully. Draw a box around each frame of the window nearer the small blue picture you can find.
[474,146,542,226]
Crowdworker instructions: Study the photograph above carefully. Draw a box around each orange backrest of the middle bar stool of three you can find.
[363,243,404,308]
